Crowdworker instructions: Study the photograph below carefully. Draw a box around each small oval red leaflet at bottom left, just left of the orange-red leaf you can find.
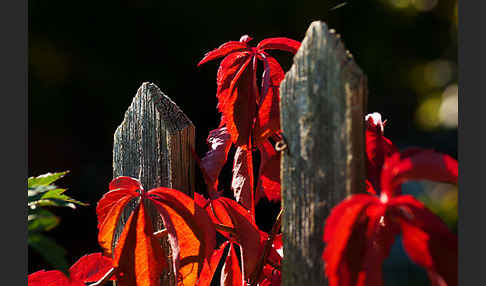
[69,252,114,283]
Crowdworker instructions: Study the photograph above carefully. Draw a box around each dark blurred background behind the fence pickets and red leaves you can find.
[28,0,458,285]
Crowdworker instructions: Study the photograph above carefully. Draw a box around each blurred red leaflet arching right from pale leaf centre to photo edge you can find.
[381,148,458,194]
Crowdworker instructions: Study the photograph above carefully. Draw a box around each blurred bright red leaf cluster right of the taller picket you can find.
[322,113,458,286]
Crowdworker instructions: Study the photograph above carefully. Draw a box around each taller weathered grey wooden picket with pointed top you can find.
[280,22,367,285]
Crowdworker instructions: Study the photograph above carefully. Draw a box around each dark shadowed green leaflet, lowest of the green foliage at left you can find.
[27,233,68,274]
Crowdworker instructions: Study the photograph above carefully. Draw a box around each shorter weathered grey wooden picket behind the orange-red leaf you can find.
[113,83,195,285]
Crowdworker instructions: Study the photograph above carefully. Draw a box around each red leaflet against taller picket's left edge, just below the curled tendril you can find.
[255,141,281,204]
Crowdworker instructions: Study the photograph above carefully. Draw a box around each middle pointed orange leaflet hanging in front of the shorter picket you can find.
[113,203,167,286]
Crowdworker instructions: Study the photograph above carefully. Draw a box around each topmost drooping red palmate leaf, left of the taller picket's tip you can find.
[200,35,300,149]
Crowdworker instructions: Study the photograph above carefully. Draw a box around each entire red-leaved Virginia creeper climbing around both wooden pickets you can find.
[28,35,458,286]
